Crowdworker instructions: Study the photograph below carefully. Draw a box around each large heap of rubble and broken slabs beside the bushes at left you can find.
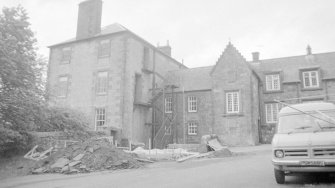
[27,138,142,174]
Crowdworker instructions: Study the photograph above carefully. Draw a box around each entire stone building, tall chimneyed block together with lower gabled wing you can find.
[48,0,335,148]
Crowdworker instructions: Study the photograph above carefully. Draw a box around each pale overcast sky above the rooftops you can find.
[0,0,335,67]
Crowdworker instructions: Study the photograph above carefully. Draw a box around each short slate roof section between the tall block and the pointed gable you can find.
[165,66,214,91]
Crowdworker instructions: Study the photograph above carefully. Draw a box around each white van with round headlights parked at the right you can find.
[272,102,335,184]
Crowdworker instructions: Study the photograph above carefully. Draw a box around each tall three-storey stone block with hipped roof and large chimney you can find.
[48,0,186,145]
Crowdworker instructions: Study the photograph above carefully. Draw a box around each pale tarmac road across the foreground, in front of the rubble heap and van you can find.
[0,151,335,188]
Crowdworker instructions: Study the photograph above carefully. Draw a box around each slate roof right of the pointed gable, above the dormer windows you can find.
[249,52,335,83]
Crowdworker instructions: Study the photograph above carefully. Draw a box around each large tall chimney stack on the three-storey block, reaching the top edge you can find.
[76,0,102,39]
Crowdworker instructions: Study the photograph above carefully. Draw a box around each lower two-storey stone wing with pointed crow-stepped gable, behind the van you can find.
[162,43,335,145]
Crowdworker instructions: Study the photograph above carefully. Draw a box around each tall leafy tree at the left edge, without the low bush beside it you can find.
[0,6,44,156]
